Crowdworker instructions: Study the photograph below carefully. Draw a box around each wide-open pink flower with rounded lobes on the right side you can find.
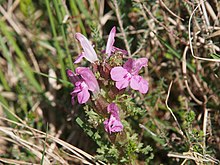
[110,58,148,94]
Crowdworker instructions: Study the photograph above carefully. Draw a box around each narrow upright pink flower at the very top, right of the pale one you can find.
[105,26,128,58]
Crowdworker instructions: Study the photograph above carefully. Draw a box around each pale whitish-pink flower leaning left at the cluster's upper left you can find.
[74,33,98,63]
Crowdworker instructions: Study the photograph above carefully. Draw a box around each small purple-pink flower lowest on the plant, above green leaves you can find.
[104,103,123,134]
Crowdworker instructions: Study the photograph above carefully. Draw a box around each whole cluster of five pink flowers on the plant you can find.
[67,27,148,134]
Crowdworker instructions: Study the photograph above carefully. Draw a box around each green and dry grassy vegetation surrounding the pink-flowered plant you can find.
[0,0,220,164]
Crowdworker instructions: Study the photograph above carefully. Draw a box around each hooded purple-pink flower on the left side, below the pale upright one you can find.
[67,67,100,104]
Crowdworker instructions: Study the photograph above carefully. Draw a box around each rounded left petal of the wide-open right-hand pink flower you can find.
[110,66,128,81]
